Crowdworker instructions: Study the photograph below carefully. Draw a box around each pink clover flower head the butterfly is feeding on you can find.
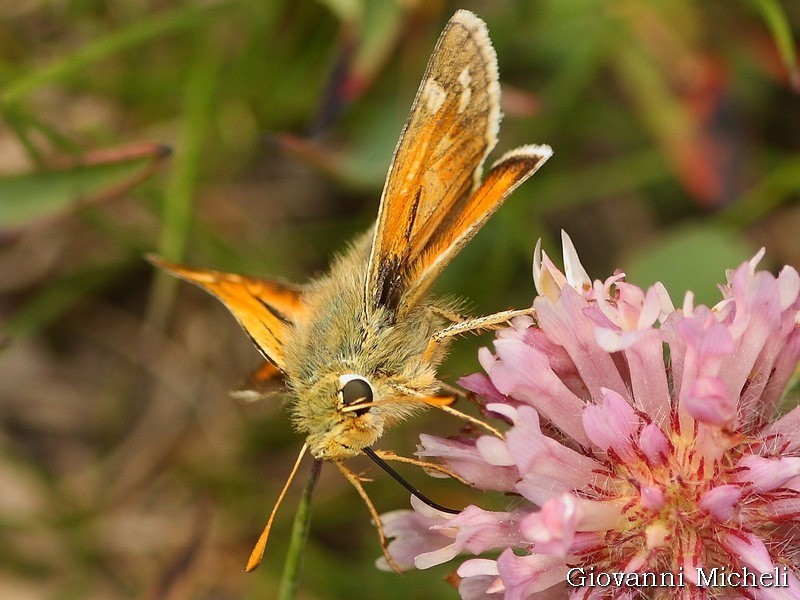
[386,234,800,600]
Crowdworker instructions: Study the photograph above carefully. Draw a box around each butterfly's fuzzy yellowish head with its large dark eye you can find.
[295,373,385,460]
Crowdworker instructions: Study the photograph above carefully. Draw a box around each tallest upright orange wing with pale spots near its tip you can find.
[365,10,500,313]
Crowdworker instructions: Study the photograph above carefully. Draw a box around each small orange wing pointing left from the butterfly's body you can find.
[147,256,305,370]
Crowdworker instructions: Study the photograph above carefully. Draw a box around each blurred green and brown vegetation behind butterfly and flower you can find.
[0,0,800,600]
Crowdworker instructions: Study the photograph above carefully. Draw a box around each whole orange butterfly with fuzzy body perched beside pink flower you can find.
[149,10,552,570]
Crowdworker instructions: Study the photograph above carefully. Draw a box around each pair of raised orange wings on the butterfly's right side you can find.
[365,11,549,315]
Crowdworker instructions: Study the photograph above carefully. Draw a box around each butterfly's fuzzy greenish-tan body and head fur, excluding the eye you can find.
[285,232,455,460]
